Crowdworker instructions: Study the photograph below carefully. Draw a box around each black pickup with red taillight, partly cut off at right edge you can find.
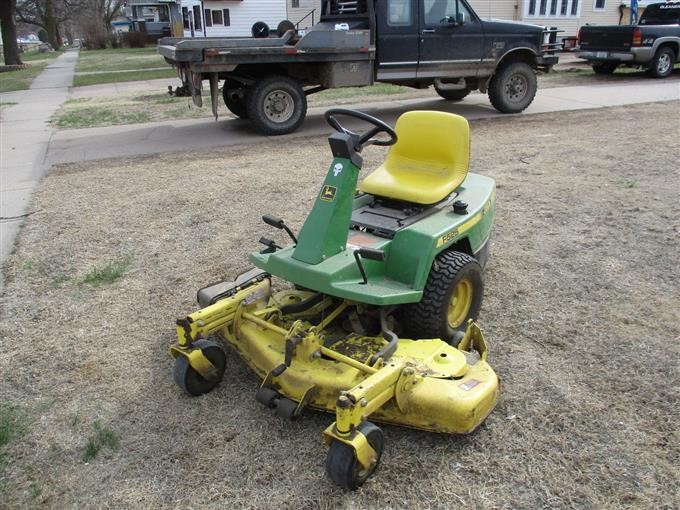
[577,2,680,78]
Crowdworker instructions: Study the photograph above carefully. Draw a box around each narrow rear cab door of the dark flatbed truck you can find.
[375,0,422,81]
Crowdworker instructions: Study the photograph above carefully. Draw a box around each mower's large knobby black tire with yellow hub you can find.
[402,251,484,342]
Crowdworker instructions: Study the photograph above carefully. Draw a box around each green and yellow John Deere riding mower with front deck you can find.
[171,109,499,489]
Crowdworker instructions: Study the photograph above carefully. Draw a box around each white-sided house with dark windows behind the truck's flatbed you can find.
[181,0,287,37]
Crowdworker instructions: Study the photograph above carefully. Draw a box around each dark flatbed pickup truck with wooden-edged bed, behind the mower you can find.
[158,0,557,135]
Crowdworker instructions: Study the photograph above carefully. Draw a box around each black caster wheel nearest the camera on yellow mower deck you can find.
[326,421,385,490]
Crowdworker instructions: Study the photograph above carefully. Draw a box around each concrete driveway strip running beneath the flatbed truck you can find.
[48,79,680,164]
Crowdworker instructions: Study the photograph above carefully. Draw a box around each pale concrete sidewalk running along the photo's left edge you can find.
[0,50,78,280]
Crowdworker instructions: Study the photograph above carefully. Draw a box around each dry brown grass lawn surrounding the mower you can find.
[0,102,680,509]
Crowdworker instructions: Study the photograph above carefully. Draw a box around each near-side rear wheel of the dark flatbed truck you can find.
[246,76,307,136]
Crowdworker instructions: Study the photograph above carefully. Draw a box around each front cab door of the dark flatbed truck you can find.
[418,0,484,78]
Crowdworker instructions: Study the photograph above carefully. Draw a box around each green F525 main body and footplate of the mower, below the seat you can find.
[250,173,495,305]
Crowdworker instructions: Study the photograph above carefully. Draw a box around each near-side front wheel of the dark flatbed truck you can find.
[489,62,537,113]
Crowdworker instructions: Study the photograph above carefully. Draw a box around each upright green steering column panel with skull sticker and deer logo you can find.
[293,158,359,264]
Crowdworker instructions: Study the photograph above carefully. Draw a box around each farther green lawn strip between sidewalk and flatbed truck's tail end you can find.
[76,46,172,73]
